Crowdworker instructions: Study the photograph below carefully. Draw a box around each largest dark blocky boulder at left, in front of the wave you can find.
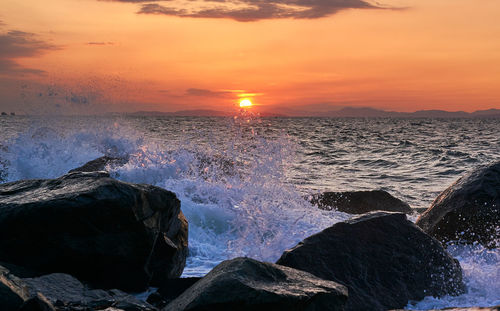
[0,172,187,290]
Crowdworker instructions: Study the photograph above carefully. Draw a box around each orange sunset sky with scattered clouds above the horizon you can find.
[0,0,500,114]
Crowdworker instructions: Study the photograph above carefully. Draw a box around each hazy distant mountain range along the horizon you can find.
[127,107,500,118]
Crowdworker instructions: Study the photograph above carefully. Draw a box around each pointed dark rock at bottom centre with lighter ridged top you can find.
[163,258,347,311]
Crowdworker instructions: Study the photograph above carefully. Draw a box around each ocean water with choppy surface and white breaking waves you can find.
[0,113,500,309]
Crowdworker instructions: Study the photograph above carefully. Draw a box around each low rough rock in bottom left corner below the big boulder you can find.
[0,266,155,311]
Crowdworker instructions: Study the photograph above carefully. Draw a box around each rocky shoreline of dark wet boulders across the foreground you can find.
[0,157,500,311]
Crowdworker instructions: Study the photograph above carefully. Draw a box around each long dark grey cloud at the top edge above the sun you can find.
[135,0,389,22]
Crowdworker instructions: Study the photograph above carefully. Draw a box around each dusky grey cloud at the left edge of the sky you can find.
[0,30,59,75]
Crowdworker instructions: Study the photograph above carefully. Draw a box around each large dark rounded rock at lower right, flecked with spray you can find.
[277,212,464,310]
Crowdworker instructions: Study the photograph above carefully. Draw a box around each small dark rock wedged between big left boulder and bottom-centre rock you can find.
[147,277,201,309]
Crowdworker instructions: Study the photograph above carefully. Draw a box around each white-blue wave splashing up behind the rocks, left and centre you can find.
[0,116,349,276]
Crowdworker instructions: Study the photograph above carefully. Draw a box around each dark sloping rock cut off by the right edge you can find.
[416,162,500,248]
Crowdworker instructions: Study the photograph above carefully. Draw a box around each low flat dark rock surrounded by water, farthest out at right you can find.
[311,190,413,214]
